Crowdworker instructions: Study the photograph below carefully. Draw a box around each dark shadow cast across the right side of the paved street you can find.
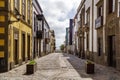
[63,54,120,80]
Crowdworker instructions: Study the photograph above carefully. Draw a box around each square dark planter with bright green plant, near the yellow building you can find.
[26,60,37,74]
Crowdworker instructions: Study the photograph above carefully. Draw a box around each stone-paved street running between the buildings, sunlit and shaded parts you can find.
[0,53,120,80]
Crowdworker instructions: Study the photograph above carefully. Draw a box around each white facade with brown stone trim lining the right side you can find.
[75,0,120,70]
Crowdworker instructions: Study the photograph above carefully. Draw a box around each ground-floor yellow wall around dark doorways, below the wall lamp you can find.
[9,22,32,62]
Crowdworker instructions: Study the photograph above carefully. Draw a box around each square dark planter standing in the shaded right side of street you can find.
[85,60,94,74]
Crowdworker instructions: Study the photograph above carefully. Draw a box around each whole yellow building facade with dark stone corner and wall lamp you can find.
[0,0,32,72]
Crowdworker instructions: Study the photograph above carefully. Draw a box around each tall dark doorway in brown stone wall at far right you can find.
[108,36,116,67]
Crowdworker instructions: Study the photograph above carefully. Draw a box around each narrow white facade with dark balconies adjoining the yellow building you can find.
[32,0,43,58]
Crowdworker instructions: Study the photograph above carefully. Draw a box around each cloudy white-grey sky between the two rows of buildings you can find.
[38,0,81,49]
